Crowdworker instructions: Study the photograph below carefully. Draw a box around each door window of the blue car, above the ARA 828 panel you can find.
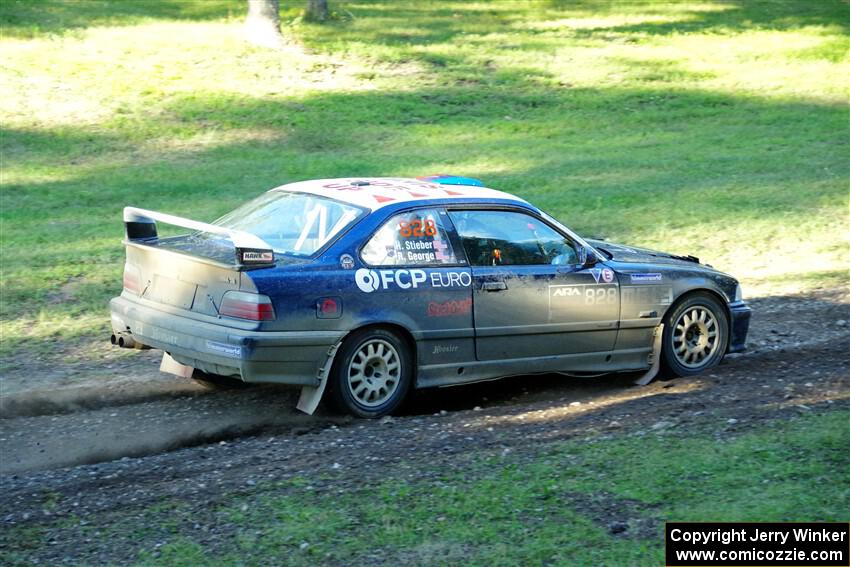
[449,211,578,266]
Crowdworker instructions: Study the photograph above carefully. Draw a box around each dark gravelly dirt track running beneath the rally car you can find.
[0,290,850,561]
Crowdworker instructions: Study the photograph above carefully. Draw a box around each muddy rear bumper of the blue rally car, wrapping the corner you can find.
[109,296,344,386]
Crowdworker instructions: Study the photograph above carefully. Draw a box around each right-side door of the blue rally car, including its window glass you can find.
[449,209,620,360]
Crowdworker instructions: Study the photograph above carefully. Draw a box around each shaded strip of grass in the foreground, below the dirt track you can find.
[6,410,850,565]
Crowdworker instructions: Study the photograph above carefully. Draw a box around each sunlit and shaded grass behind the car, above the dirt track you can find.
[0,0,850,353]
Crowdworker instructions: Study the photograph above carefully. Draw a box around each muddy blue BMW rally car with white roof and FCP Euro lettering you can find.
[110,176,750,417]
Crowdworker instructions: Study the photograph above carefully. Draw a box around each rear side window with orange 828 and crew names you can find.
[360,209,458,266]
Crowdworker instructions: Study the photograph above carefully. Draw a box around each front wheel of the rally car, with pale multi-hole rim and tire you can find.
[661,292,729,376]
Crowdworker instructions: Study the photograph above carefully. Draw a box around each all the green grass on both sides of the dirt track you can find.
[0,0,850,565]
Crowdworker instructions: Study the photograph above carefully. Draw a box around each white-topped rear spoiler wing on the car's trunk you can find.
[124,207,274,267]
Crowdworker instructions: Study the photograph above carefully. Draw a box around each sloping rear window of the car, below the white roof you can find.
[213,191,365,256]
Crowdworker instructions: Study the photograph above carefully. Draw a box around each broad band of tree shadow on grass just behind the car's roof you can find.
[2,79,847,245]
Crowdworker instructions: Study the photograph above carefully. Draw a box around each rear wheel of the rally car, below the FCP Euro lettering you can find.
[328,328,413,419]
